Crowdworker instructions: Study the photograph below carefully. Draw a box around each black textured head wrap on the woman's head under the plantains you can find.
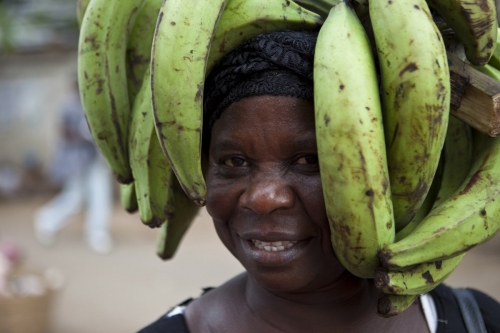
[203,31,318,138]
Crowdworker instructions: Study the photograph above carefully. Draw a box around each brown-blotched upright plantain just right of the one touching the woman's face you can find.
[370,0,451,231]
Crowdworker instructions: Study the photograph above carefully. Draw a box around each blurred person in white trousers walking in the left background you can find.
[34,83,113,254]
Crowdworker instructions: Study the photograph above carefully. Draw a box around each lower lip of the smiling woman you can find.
[241,238,310,266]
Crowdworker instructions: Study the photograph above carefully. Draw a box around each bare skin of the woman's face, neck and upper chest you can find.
[186,96,429,333]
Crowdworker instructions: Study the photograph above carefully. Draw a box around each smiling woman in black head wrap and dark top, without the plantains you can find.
[141,31,500,333]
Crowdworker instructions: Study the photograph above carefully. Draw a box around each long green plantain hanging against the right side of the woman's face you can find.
[314,1,394,278]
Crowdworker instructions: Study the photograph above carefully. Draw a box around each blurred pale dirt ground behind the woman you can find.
[0,195,500,333]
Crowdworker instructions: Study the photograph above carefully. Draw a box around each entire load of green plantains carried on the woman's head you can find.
[78,0,500,316]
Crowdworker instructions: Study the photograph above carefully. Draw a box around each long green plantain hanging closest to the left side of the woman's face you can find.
[151,0,228,205]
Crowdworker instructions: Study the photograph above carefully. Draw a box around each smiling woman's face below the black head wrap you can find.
[207,96,344,292]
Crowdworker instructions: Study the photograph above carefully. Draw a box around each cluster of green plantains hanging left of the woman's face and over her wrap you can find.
[77,0,323,259]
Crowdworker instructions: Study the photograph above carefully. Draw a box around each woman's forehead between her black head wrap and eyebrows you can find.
[212,95,315,143]
